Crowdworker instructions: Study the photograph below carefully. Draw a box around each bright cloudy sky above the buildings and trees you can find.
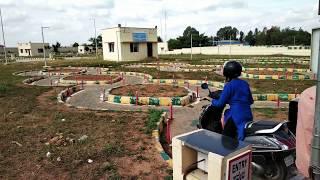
[0,0,319,46]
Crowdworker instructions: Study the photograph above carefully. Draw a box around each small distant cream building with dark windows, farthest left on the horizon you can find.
[18,42,49,57]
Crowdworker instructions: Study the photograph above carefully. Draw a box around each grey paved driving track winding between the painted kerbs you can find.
[20,68,288,137]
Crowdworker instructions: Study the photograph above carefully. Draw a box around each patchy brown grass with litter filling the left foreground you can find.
[0,61,170,179]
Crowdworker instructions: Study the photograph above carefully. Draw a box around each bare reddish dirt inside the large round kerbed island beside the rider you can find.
[110,84,188,97]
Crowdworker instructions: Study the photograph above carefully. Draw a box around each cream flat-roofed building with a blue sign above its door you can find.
[102,24,158,61]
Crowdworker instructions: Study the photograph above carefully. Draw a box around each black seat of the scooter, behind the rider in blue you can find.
[245,120,279,135]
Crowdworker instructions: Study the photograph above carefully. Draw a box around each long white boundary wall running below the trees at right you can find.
[162,45,311,56]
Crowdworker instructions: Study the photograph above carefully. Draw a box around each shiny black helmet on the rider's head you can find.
[223,61,242,80]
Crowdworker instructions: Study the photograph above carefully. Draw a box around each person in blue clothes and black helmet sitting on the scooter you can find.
[211,61,253,140]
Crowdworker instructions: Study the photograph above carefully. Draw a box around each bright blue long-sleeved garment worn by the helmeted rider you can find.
[212,78,253,140]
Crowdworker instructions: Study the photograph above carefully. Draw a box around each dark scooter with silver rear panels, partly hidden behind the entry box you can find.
[198,83,296,180]
